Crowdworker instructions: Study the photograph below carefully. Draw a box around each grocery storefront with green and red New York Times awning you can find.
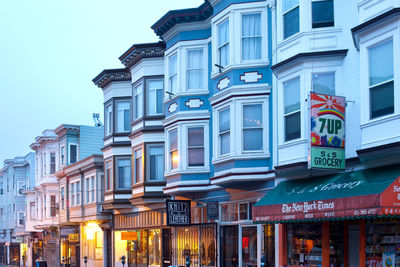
[253,167,400,267]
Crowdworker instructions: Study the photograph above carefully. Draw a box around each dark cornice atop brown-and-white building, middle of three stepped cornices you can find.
[119,41,165,68]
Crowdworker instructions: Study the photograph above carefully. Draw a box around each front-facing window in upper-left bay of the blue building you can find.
[186,49,204,90]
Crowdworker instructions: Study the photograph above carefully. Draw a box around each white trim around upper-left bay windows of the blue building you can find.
[164,39,210,99]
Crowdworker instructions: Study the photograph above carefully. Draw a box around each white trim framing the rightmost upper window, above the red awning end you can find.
[360,28,400,127]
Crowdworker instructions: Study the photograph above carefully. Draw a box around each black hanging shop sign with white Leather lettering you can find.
[166,200,191,226]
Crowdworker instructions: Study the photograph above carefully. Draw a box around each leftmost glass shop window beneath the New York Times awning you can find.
[287,224,322,266]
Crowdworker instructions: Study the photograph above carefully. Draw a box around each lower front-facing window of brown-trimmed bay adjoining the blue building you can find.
[147,144,164,181]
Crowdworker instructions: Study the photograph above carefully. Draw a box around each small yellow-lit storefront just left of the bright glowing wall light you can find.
[60,226,80,267]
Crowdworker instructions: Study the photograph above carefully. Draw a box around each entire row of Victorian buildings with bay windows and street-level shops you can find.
[0,0,400,267]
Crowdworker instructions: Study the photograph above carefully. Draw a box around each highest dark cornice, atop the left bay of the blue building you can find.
[151,0,213,37]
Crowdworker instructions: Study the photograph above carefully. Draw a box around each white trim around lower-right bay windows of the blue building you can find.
[212,95,270,164]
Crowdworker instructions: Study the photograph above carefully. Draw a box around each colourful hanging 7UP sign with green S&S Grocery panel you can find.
[308,93,346,170]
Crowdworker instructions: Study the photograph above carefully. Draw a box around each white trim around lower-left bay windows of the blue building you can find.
[164,119,210,176]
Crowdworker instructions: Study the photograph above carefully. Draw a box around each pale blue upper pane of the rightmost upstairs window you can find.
[369,40,393,85]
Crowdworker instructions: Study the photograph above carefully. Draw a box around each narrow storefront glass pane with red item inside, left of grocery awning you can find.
[242,226,257,267]
